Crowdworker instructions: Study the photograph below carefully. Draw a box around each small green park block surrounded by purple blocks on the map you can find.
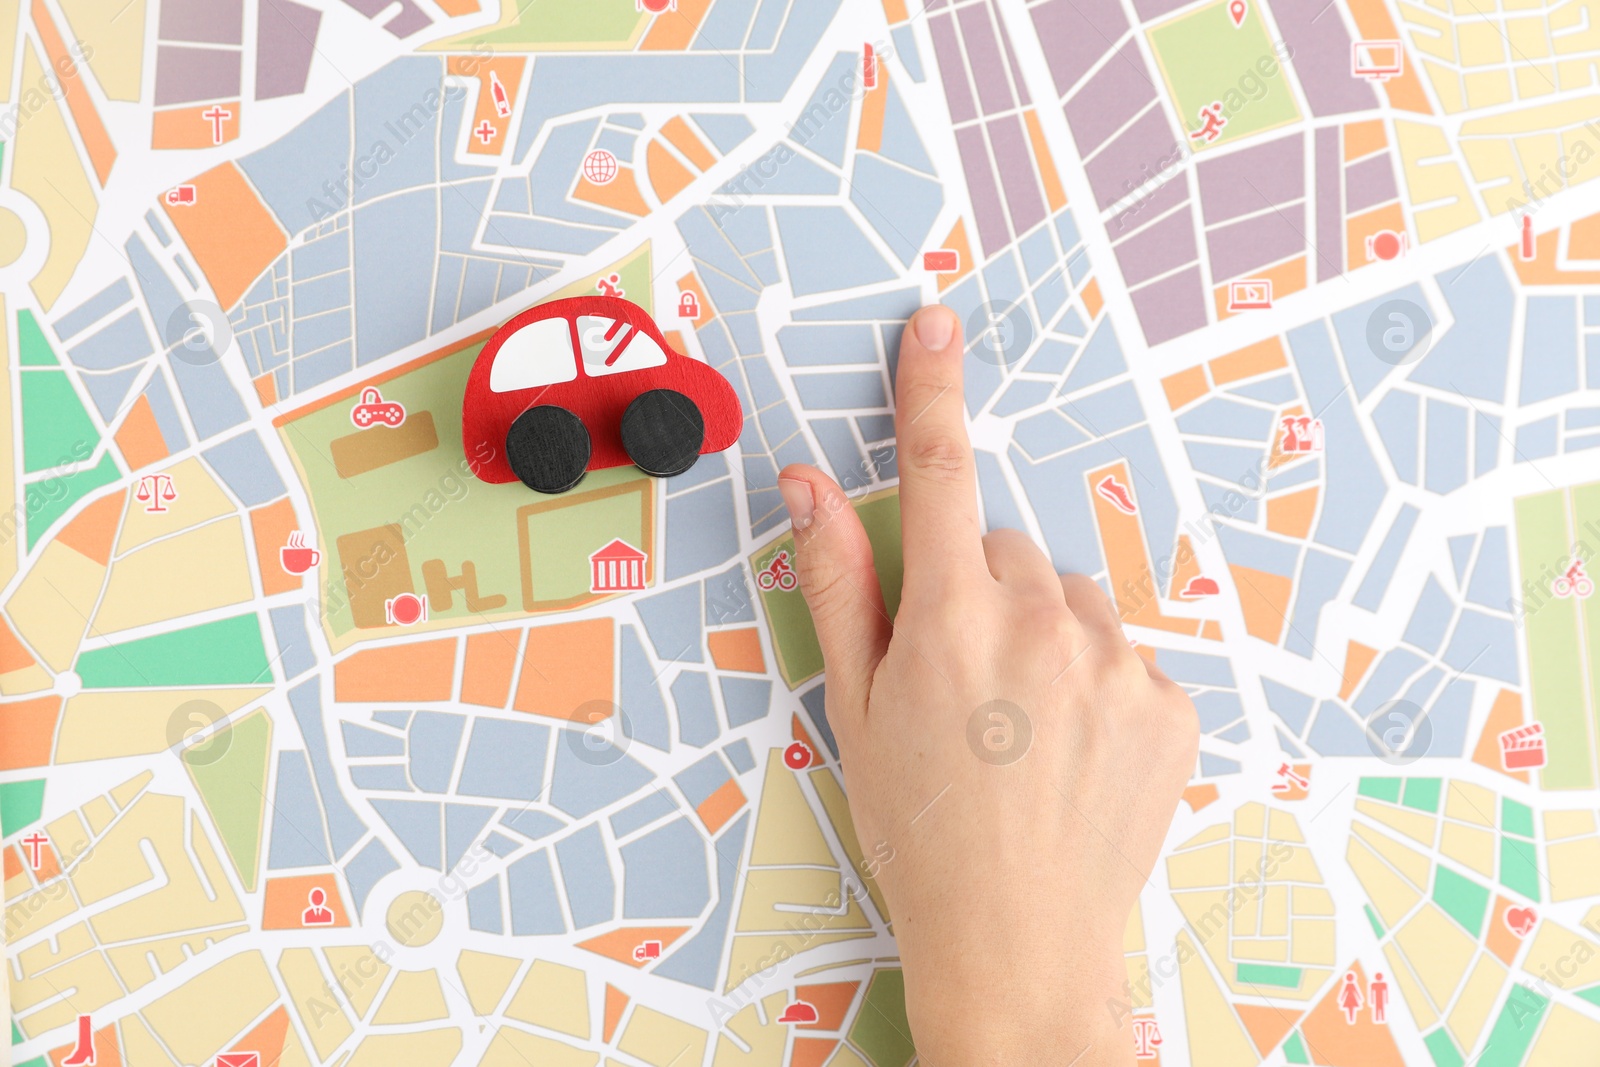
[1149,0,1299,152]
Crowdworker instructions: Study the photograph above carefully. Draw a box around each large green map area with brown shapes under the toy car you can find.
[278,338,658,649]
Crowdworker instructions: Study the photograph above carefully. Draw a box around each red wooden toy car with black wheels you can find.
[461,296,744,493]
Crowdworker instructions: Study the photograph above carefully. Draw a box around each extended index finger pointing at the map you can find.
[894,304,989,584]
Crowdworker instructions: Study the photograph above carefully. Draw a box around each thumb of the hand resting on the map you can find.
[778,464,893,715]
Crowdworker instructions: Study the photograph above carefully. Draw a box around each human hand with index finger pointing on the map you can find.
[778,306,1198,1067]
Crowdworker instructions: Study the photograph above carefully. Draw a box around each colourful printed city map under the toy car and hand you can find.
[0,0,1600,1067]
